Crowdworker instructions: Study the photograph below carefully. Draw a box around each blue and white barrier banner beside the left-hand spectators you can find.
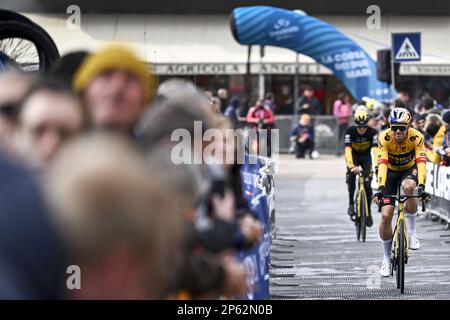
[238,155,275,300]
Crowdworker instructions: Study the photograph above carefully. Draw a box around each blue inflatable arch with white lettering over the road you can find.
[231,6,395,100]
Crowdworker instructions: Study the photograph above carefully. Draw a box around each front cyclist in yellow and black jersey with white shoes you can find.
[375,108,429,277]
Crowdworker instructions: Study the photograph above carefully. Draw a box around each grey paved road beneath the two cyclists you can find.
[270,155,450,299]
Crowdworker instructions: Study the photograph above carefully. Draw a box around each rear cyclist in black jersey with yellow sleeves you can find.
[344,106,378,227]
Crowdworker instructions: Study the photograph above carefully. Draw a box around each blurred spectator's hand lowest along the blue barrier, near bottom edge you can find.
[221,255,249,298]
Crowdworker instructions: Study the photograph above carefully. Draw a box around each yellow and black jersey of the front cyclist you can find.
[378,128,427,187]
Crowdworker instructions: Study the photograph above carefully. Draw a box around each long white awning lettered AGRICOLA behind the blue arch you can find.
[23,13,450,74]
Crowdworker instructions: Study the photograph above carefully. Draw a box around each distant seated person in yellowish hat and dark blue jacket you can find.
[291,114,314,159]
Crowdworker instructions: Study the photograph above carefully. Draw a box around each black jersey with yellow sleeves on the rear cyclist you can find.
[344,126,378,168]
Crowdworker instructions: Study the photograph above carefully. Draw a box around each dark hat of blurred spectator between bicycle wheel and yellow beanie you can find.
[50,50,89,86]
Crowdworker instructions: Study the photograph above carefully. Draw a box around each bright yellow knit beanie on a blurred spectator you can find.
[73,44,156,102]
